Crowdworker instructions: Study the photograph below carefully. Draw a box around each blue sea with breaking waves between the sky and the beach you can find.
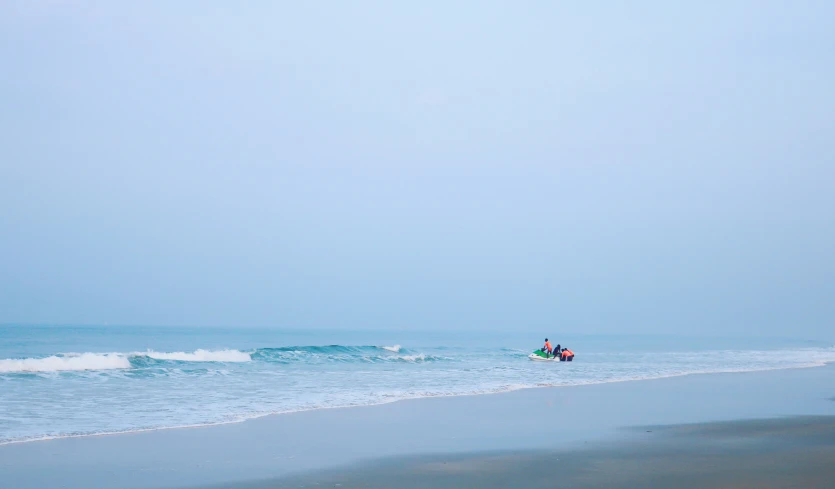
[0,326,835,443]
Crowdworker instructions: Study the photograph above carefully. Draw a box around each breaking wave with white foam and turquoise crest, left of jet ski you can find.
[0,345,447,374]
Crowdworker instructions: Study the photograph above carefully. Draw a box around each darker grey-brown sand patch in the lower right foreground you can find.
[233,416,835,489]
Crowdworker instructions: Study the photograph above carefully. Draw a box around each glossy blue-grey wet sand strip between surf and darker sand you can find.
[0,365,835,489]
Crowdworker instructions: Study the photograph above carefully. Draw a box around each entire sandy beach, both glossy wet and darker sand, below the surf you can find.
[0,366,835,489]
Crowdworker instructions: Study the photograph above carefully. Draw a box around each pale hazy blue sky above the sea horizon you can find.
[0,0,835,339]
